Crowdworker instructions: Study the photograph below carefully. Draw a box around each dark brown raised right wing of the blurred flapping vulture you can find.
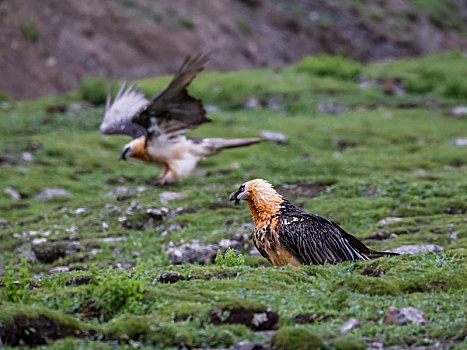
[132,55,211,136]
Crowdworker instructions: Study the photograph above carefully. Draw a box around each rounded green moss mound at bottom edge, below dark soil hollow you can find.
[271,327,323,350]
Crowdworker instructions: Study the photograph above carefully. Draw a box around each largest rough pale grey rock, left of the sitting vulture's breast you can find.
[165,240,219,264]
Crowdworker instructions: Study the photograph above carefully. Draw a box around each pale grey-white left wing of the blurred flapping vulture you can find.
[99,82,149,138]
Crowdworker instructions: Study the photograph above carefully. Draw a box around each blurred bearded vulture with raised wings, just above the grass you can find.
[99,55,262,185]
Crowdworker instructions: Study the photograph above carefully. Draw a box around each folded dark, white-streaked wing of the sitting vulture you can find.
[276,213,372,265]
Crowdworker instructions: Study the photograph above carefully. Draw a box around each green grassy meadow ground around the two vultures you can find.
[0,53,467,349]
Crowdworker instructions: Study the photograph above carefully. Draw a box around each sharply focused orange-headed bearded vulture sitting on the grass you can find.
[230,179,398,266]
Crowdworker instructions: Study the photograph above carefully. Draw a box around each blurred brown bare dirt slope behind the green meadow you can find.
[0,0,467,98]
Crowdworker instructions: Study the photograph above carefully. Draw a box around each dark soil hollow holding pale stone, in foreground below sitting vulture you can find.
[210,306,279,331]
